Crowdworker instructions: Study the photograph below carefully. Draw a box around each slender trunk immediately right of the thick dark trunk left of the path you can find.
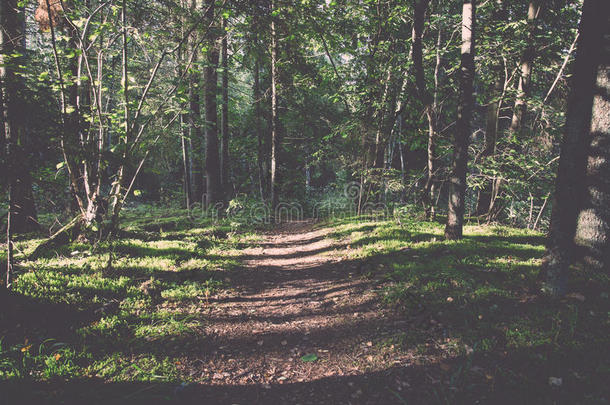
[220,18,231,198]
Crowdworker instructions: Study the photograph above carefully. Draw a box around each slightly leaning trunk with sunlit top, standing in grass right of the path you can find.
[445,0,475,240]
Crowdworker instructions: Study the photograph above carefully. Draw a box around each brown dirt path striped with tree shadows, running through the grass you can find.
[178,224,428,403]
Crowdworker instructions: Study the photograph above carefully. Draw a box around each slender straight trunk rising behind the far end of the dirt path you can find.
[271,0,280,213]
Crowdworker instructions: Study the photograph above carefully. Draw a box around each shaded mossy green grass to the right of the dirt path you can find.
[325,218,610,403]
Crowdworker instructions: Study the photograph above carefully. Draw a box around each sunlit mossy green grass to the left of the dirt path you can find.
[0,207,255,381]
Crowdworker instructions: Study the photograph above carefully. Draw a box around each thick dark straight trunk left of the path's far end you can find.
[203,0,223,208]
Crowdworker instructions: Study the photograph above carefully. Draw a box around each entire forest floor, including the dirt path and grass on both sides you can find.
[0,207,610,404]
